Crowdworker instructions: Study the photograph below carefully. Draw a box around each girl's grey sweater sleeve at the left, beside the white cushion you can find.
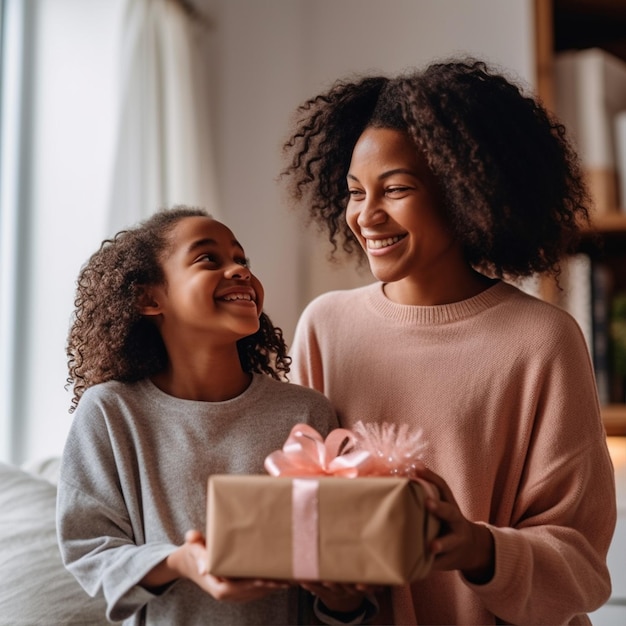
[57,394,176,620]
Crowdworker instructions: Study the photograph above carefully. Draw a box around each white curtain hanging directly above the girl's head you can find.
[107,0,221,235]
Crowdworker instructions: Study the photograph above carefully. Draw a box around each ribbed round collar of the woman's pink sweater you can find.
[368,281,517,325]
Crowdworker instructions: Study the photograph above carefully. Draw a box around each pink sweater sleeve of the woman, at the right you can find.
[465,326,616,624]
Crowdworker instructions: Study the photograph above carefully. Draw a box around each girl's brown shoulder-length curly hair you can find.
[66,206,291,412]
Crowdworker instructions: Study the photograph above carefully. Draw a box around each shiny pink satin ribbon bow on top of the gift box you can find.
[265,424,371,478]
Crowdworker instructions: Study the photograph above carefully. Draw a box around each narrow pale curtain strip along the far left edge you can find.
[0,0,36,462]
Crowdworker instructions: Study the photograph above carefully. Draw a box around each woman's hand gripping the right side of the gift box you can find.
[416,468,495,584]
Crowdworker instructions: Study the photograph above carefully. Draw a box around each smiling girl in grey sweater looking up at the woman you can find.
[58,207,336,626]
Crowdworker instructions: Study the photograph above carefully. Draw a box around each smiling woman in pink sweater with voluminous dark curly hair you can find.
[283,59,615,624]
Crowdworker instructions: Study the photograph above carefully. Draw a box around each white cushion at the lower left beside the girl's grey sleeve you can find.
[0,463,109,626]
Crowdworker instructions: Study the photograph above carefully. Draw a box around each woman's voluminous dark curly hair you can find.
[280,58,590,278]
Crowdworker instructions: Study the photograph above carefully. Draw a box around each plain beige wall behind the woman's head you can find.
[207,0,535,340]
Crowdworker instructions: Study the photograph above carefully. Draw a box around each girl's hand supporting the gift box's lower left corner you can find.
[142,530,289,602]
